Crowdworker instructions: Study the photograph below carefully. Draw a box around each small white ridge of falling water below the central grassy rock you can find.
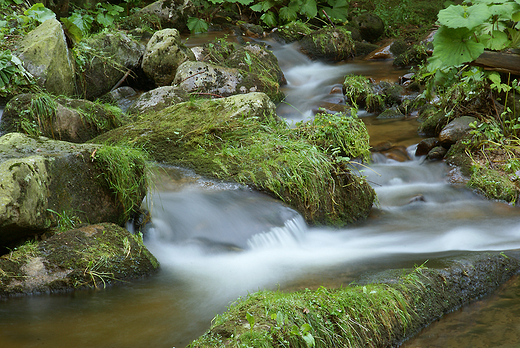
[247,215,307,250]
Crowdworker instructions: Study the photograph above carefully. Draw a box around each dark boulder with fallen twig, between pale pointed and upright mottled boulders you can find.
[77,31,145,100]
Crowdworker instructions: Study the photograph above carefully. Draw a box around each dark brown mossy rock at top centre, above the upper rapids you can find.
[300,27,354,61]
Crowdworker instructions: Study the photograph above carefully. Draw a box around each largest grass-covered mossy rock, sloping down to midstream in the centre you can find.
[94,93,375,225]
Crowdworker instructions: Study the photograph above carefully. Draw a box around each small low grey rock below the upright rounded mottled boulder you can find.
[128,86,189,115]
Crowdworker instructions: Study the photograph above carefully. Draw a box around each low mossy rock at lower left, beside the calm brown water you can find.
[0,223,159,298]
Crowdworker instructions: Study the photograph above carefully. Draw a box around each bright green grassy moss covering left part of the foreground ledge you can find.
[189,284,413,348]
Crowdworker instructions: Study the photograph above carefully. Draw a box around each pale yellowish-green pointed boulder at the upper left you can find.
[16,19,75,96]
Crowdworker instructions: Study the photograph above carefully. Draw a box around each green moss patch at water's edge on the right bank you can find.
[468,165,519,204]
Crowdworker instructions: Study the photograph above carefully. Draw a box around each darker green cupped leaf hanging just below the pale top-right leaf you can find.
[429,26,485,69]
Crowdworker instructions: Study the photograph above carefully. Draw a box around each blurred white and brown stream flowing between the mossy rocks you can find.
[0,38,520,348]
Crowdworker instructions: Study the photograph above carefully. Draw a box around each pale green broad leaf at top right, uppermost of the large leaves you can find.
[438,4,491,29]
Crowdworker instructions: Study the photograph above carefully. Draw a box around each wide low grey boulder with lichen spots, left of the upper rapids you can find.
[173,62,283,101]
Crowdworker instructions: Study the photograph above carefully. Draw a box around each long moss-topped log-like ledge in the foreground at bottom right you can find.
[190,252,520,348]
